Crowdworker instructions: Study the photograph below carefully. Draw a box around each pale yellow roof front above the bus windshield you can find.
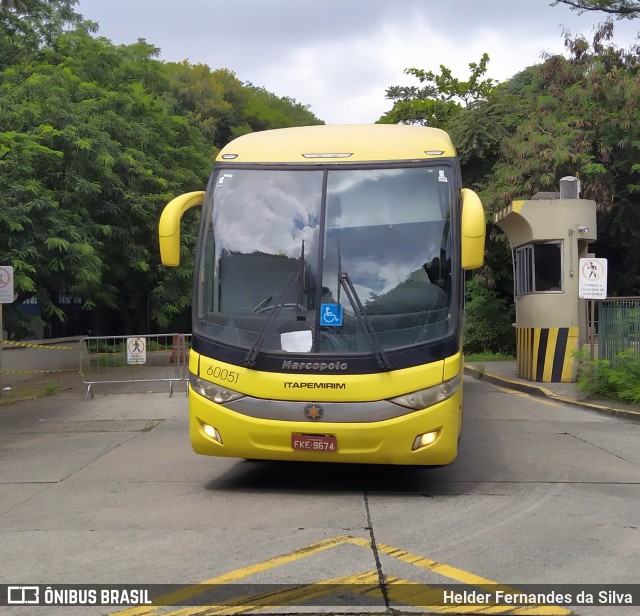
[216,124,456,164]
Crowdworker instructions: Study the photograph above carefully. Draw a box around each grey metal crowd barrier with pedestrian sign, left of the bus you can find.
[80,334,191,398]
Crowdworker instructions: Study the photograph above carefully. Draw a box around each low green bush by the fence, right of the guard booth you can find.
[575,349,640,404]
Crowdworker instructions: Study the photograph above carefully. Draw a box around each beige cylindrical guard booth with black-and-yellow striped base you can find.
[494,177,597,383]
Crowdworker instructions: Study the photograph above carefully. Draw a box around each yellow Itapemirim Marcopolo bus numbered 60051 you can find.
[159,125,485,465]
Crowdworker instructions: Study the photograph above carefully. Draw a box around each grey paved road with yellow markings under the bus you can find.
[0,378,640,616]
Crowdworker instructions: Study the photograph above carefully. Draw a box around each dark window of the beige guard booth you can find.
[516,241,562,295]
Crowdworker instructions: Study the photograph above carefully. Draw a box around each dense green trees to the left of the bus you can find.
[0,7,320,337]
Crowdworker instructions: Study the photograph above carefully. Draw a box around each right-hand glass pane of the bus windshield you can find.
[320,167,451,352]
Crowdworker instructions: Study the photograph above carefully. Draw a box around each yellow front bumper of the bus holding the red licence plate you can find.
[189,389,462,466]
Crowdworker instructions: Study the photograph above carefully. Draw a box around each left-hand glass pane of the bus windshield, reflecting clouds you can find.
[197,169,323,352]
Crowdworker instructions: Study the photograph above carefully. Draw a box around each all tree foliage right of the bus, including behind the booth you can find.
[380,21,640,316]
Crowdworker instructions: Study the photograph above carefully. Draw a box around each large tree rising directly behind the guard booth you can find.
[483,21,640,295]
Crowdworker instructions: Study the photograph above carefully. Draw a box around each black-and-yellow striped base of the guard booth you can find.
[516,327,578,383]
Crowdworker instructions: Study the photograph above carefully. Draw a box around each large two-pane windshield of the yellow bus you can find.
[194,161,460,356]
